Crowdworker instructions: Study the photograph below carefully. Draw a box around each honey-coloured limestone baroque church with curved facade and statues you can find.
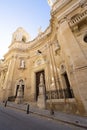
[0,0,87,115]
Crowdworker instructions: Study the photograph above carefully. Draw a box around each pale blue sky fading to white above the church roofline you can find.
[0,0,50,59]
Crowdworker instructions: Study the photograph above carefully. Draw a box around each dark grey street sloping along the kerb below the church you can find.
[0,106,85,130]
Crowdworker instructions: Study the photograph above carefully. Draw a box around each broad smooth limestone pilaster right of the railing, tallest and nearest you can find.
[57,20,87,113]
